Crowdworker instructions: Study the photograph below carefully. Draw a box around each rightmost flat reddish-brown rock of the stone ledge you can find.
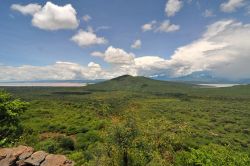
[41,154,73,166]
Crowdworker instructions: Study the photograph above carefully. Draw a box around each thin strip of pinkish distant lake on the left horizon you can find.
[0,82,87,87]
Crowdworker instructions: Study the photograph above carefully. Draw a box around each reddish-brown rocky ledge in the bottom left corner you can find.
[0,145,74,166]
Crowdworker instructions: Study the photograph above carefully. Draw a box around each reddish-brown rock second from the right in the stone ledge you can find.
[24,151,48,166]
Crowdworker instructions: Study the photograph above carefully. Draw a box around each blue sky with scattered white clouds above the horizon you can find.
[0,0,250,80]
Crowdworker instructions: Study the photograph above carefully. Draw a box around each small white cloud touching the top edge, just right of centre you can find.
[165,0,183,17]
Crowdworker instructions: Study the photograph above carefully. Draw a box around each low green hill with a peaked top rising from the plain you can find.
[85,75,195,92]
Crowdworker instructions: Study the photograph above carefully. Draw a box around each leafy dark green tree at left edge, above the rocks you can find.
[0,91,28,146]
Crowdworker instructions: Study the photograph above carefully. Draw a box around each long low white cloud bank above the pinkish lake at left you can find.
[0,61,109,81]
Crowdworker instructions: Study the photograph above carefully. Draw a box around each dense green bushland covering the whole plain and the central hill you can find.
[0,76,250,166]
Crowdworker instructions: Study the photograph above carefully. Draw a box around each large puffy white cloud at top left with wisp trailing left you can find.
[11,2,79,30]
